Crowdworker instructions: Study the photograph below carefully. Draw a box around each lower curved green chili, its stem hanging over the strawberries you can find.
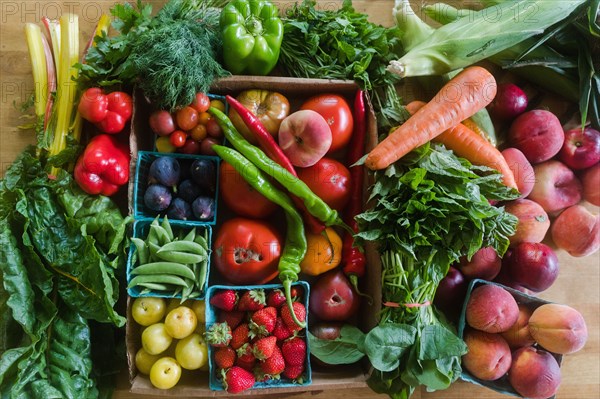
[212,145,308,327]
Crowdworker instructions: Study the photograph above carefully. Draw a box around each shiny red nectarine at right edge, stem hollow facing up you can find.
[558,127,600,170]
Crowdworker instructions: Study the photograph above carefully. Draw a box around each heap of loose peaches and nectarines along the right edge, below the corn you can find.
[492,84,600,257]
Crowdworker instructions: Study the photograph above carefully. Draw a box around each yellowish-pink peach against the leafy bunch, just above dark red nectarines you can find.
[504,198,550,245]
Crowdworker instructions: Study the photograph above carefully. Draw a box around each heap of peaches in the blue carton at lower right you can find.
[462,283,588,399]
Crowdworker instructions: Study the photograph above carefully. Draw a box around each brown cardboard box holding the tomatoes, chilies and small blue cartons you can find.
[126,76,381,397]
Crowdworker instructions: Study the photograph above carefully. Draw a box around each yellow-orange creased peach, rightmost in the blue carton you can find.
[529,303,588,355]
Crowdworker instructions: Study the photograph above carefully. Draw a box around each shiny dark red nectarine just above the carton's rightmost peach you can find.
[506,242,559,292]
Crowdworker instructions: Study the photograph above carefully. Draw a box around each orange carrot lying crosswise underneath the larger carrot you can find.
[406,101,517,188]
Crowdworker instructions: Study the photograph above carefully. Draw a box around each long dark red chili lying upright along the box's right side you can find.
[342,90,367,291]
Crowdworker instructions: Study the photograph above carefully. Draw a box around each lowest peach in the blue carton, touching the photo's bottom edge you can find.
[508,346,561,399]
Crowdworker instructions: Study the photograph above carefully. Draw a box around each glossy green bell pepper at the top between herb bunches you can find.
[220,0,283,75]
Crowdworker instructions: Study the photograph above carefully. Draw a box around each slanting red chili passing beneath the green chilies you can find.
[225,95,325,234]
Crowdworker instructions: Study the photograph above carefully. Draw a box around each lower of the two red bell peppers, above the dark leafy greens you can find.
[73,134,130,196]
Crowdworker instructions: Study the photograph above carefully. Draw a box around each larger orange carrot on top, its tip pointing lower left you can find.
[365,66,496,170]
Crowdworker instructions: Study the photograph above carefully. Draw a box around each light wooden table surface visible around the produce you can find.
[0,0,600,399]
